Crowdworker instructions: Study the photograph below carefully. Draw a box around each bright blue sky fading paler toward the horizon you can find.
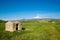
[0,0,60,20]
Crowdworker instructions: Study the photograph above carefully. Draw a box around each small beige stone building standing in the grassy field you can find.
[5,21,22,32]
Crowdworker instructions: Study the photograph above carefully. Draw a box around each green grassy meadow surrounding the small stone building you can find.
[0,20,60,40]
